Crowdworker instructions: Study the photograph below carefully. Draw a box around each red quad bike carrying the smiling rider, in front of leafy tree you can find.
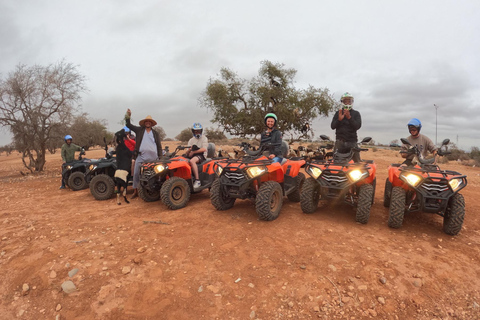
[210,145,305,221]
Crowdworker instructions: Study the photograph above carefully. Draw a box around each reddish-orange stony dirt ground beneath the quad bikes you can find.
[0,143,480,320]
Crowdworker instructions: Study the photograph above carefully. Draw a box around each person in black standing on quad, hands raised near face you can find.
[331,92,362,162]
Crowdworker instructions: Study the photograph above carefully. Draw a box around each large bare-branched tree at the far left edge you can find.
[0,61,86,172]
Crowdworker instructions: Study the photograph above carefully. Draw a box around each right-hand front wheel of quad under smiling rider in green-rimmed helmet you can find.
[255,181,283,221]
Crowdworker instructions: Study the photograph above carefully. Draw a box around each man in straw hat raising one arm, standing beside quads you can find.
[125,109,162,199]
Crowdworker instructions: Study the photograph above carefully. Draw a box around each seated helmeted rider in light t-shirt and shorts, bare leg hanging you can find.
[187,122,208,189]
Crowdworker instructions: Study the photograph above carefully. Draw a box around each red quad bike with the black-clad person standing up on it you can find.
[300,135,377,224]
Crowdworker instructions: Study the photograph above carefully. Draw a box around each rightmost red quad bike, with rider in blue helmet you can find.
[383,138,467,235]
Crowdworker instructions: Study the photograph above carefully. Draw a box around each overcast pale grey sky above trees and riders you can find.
[0,0,480,151]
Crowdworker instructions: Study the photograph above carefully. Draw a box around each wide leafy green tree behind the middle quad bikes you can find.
[199,61,336,140]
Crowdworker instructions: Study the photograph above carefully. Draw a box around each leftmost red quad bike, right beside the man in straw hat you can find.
[138,143,215,210]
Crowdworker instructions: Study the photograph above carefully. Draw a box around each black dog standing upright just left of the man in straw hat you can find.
[115,129,133,205]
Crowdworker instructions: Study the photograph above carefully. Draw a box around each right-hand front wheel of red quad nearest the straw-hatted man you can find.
[160,177,190,210]
